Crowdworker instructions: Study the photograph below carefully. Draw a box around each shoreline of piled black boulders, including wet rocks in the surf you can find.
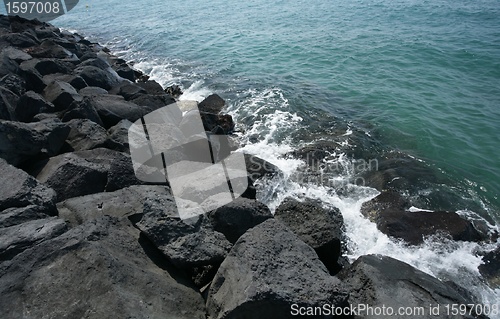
[0,16,499,319]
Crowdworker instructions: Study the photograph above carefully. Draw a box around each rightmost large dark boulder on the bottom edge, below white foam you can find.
[338,255,482,318]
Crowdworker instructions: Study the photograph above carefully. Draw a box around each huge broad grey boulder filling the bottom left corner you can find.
[0,217,205,319]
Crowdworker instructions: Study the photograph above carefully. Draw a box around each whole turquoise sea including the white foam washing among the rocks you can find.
[7,0,500,303]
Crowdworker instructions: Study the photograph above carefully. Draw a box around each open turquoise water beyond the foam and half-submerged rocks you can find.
[7,0,500,216]
